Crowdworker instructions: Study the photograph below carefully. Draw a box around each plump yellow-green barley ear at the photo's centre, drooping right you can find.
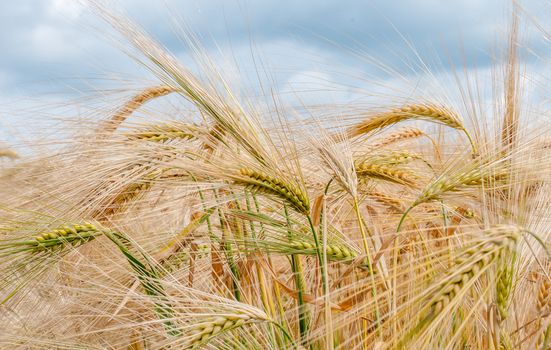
[238,168,310,214]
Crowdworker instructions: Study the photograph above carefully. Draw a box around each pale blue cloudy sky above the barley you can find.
[0,0,551,144]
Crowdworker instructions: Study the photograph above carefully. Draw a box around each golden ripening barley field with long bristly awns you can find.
[0,2,551,350]
